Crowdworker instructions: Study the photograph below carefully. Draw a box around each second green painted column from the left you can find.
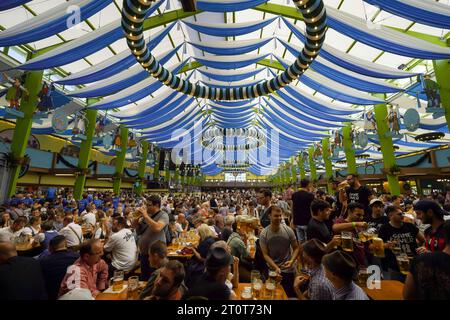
[73,108,97,200]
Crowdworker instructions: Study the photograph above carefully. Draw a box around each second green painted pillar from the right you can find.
[374,94,400,195]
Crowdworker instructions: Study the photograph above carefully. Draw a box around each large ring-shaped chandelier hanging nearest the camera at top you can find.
[122,0,327,101]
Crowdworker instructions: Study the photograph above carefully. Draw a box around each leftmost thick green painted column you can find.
[8,54,44,197]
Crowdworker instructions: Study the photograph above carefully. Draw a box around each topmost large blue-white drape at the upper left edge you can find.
[0,0,112,47]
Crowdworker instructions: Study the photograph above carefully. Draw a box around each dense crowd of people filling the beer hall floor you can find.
[0,175,450,300]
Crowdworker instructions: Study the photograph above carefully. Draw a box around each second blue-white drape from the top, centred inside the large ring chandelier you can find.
[182,18,276,37]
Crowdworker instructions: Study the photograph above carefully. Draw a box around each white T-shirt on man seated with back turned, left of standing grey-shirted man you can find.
[104,228,137,271]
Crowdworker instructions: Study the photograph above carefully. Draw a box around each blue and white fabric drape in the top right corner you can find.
[364,0,450,29]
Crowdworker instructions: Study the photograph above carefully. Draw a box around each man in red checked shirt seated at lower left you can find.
[59,239,108,298]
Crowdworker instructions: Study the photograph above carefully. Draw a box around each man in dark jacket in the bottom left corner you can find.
[0,241,47,300]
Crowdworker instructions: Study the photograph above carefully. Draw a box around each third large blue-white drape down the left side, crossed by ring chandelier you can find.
[56,23,175,85]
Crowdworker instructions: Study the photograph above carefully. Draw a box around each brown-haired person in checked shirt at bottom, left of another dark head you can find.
[294,239,333,300]
